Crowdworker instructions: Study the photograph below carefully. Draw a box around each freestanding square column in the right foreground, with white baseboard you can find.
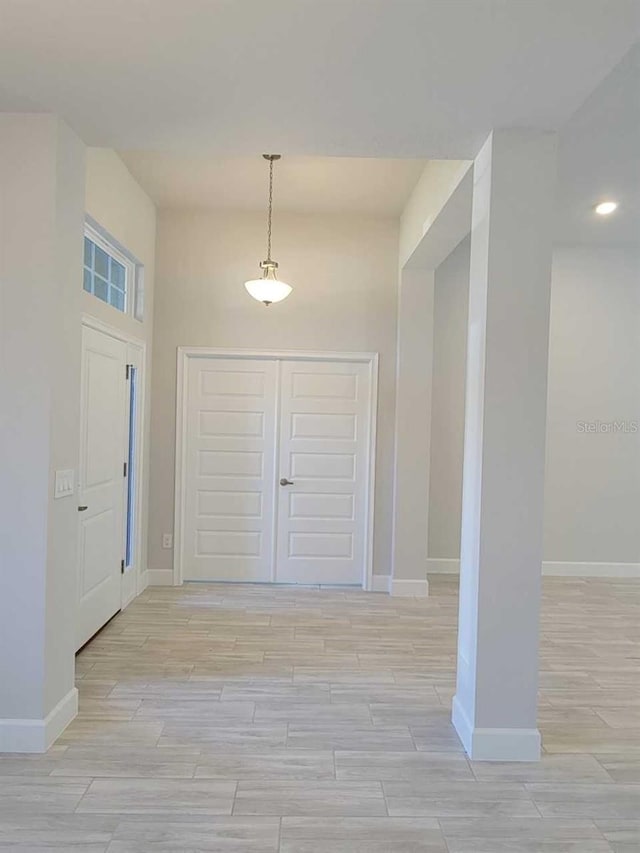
[453,130,556,761]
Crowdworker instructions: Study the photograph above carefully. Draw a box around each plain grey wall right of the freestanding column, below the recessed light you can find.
[544,247,640,564]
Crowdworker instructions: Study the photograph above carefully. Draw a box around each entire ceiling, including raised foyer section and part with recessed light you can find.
[0,0,640,244]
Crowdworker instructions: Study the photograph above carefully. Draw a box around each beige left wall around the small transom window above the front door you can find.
[82,148,156,598]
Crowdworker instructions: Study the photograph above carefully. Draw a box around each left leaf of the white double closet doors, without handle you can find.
[184,358,277,581]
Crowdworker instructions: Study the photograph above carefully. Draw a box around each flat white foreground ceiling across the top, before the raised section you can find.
[0,0,640,159]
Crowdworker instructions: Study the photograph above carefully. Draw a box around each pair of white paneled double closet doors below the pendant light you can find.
[181,357,372,585]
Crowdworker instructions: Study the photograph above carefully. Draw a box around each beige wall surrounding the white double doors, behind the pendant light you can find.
[149,211,398,582]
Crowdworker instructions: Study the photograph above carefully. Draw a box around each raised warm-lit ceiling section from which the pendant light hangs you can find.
[118,156,426,216]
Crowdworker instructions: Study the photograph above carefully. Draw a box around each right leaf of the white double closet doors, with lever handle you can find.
[276,361,370,584]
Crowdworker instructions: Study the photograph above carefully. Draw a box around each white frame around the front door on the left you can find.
[82,313,147,610]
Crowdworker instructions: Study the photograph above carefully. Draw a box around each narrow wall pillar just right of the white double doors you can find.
[389,269,434,596]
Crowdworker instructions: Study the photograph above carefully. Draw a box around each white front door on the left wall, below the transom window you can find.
[76,326,127,648]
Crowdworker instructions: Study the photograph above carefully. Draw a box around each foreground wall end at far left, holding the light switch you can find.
[0,114,84,752]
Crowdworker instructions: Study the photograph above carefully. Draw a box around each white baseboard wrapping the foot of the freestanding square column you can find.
[452,696,541,761]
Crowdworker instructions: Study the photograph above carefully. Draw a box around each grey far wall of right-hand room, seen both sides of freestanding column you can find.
[429,245,640,571]
